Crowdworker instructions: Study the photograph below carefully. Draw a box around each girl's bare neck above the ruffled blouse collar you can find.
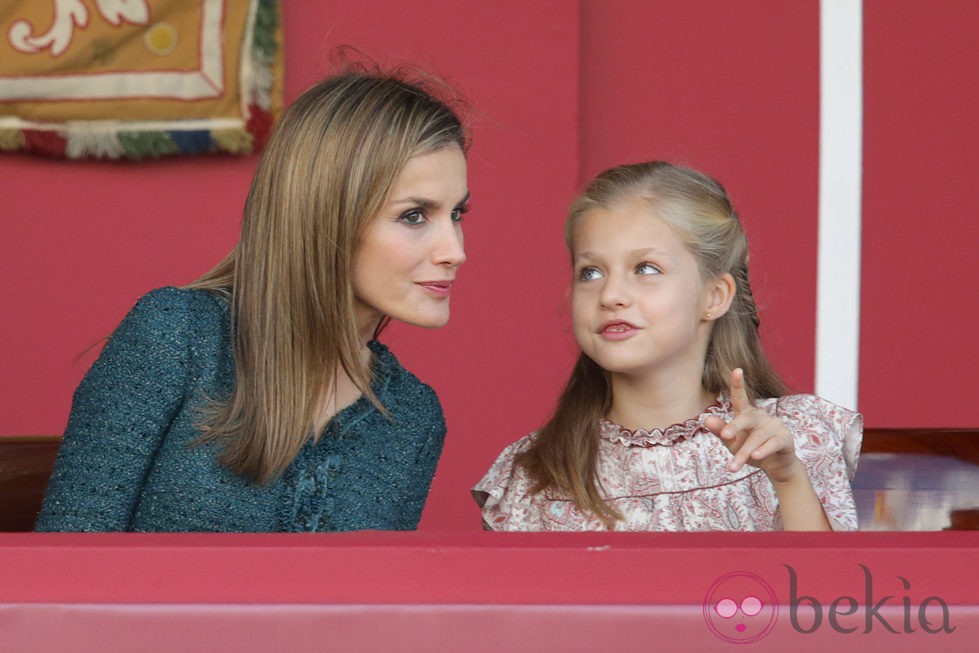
[608,374,716,431]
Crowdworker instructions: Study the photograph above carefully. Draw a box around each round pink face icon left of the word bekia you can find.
[704,571,778,644]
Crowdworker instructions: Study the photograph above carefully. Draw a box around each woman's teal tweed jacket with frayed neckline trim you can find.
[36,288,445,532]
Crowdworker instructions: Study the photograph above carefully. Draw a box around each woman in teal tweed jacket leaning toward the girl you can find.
[36,70,469,531]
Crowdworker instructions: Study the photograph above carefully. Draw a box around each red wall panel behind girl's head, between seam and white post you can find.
[580,0,819,392]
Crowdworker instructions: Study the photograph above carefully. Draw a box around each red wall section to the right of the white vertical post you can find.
[860,0,979,428]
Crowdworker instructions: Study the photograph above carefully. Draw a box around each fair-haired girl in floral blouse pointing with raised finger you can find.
[473,162,862,531]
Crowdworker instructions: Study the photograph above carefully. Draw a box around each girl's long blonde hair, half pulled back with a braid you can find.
[515,161,787,528]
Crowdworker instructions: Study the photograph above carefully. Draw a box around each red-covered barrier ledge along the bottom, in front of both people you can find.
[0,532,979,652]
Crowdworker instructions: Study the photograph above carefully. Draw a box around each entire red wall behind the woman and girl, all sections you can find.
[0,0,979,529]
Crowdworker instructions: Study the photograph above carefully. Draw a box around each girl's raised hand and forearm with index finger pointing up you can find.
[705,369,832,531]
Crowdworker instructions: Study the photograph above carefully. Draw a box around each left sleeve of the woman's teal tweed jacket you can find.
[35,288,188,531]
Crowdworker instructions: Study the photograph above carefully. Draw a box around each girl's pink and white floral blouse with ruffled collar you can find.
[472,395,863,531]
